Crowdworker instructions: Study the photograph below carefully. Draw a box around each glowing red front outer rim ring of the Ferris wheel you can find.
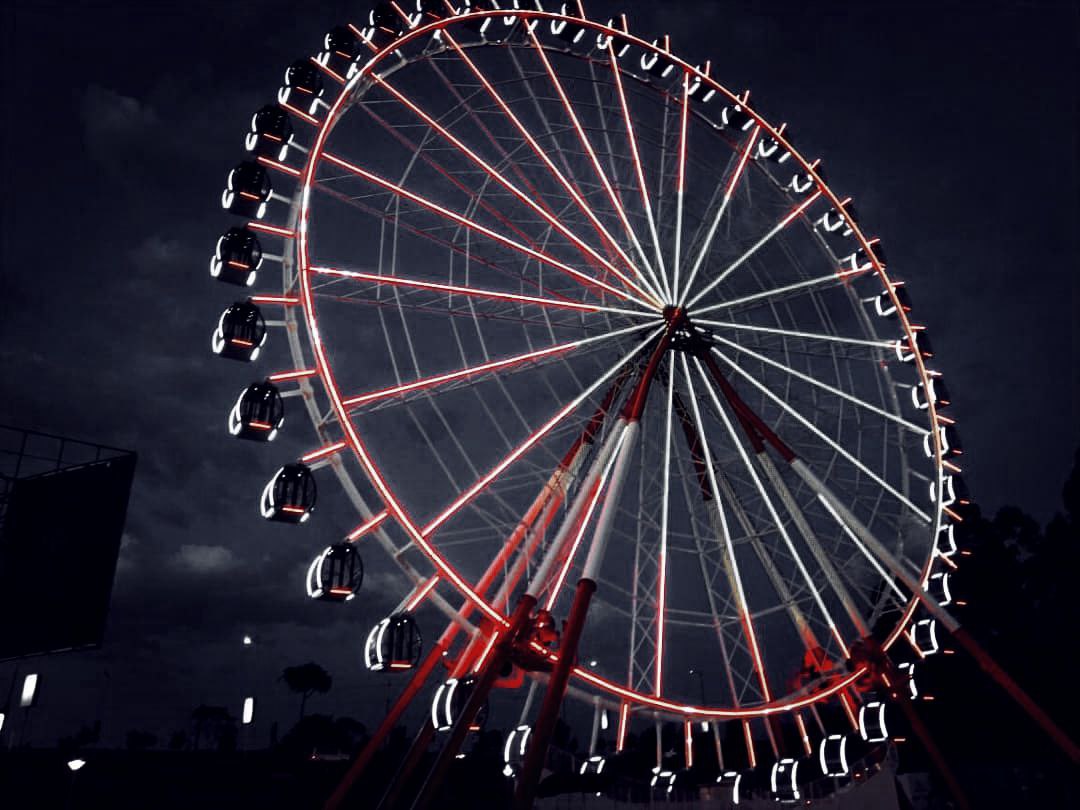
[285,9,944,719]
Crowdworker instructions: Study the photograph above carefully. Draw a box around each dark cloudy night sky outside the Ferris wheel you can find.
[0,0,1080,743]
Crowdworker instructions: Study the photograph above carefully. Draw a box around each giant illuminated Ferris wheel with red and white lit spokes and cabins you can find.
[203,0,1071,807]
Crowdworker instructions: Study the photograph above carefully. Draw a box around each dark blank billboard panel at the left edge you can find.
[0,453,135,660]
